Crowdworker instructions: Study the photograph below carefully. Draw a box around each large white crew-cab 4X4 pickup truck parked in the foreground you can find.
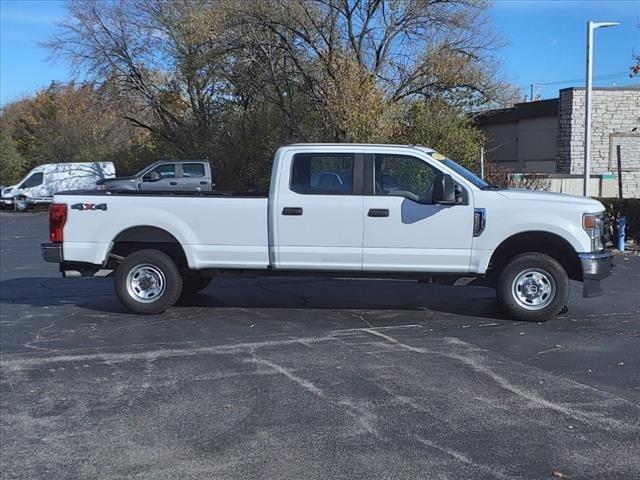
[42,144,612,321]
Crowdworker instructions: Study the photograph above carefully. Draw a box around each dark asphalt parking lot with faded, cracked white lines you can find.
[0,213,640,480]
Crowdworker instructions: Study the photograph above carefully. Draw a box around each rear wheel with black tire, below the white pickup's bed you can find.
[115,250,182,315]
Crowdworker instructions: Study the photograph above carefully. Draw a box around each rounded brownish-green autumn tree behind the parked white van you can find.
[3,83,155,173]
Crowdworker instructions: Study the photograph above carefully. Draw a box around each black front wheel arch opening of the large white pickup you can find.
[487,230,582,281]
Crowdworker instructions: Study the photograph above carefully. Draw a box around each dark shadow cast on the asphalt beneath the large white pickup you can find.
[0,277,507,319]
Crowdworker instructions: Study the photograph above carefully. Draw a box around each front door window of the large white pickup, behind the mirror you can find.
[374,155,439,203]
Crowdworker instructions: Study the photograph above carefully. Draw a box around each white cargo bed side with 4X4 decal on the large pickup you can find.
[54,190,269,269]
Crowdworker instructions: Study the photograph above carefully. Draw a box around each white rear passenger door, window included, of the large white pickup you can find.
[272,150,363,271]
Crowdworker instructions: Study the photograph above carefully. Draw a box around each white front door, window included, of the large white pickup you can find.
[363,154,473,273]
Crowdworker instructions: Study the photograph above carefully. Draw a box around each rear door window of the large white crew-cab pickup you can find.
[290,153,353,195]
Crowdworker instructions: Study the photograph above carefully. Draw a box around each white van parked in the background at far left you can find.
[2,162,116,209]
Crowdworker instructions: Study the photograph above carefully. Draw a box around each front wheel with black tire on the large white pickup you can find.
[496,252,569,322]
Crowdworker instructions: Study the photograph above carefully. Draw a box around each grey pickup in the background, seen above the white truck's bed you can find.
[97,160,213,192]
